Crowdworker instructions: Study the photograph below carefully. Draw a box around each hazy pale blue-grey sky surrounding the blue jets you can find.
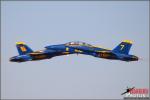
[1,1,149,99]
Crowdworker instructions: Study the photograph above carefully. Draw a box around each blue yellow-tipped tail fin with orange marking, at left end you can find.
[16,42,33,55]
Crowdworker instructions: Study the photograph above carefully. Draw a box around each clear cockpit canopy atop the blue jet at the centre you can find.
[65,41,93,47]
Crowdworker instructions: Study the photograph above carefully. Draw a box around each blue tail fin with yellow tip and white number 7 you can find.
[112,40,132,54]
